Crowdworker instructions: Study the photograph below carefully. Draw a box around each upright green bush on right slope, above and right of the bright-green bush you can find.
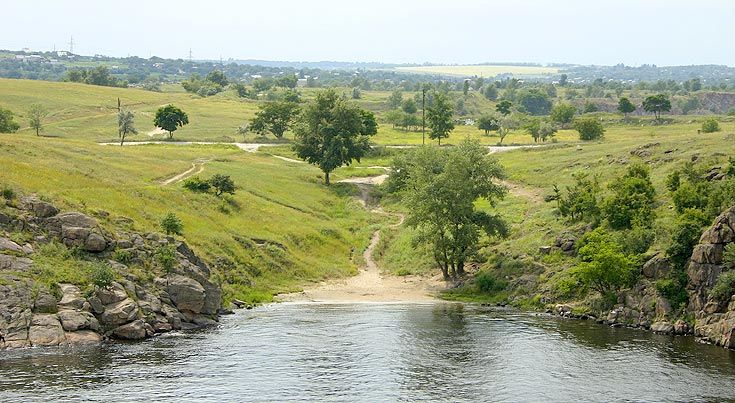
[603,164,656,229]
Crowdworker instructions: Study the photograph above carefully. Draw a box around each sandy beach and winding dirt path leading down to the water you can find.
[277,180,446,303]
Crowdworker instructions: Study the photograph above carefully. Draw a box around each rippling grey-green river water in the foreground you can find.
[0,303,735,402]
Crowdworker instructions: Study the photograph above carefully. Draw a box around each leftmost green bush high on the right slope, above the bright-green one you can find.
[545,172,601,226]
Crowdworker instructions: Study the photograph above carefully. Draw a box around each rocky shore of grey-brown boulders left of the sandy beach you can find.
[0,197,222,349]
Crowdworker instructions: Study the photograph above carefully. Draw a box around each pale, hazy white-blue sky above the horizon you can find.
[0,0,735,66]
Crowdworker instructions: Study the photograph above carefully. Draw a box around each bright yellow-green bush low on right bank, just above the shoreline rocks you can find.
[573,228,637,295]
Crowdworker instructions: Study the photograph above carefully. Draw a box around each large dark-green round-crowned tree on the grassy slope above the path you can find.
[293,90,378,185]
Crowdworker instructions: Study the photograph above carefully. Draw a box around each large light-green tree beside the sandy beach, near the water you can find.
[389,140,508,279]
